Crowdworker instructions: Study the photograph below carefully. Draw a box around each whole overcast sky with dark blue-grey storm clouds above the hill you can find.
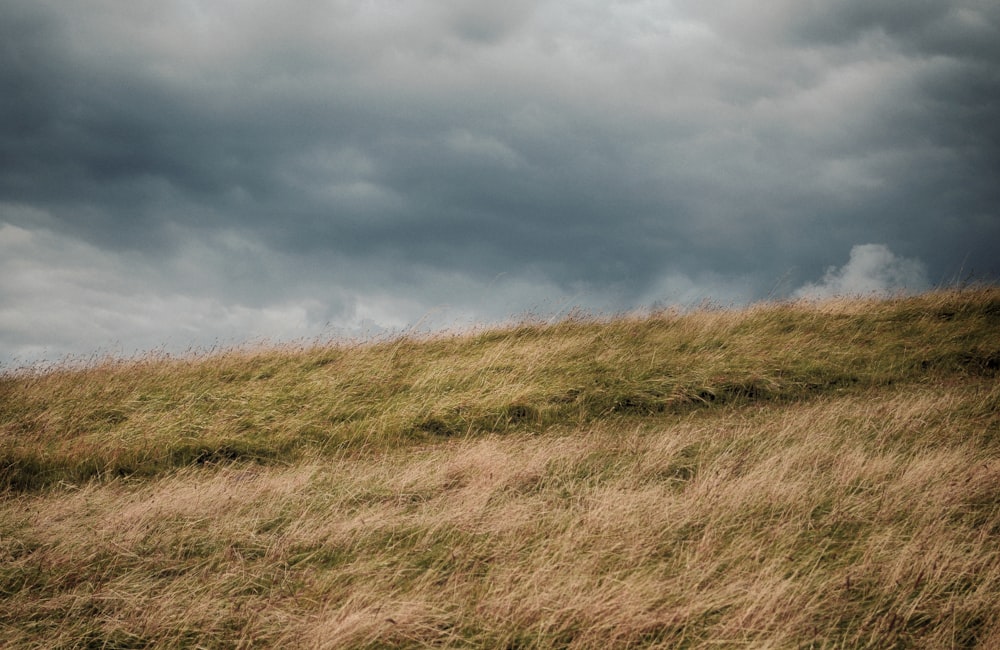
[0,0,1000,367]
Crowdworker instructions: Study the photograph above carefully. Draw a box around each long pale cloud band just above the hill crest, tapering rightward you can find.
[0,220,608,371]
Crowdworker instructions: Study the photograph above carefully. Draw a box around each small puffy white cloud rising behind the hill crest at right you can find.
[794,244,930,298]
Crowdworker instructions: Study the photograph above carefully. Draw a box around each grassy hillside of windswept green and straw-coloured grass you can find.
[0,287,1000,648]
